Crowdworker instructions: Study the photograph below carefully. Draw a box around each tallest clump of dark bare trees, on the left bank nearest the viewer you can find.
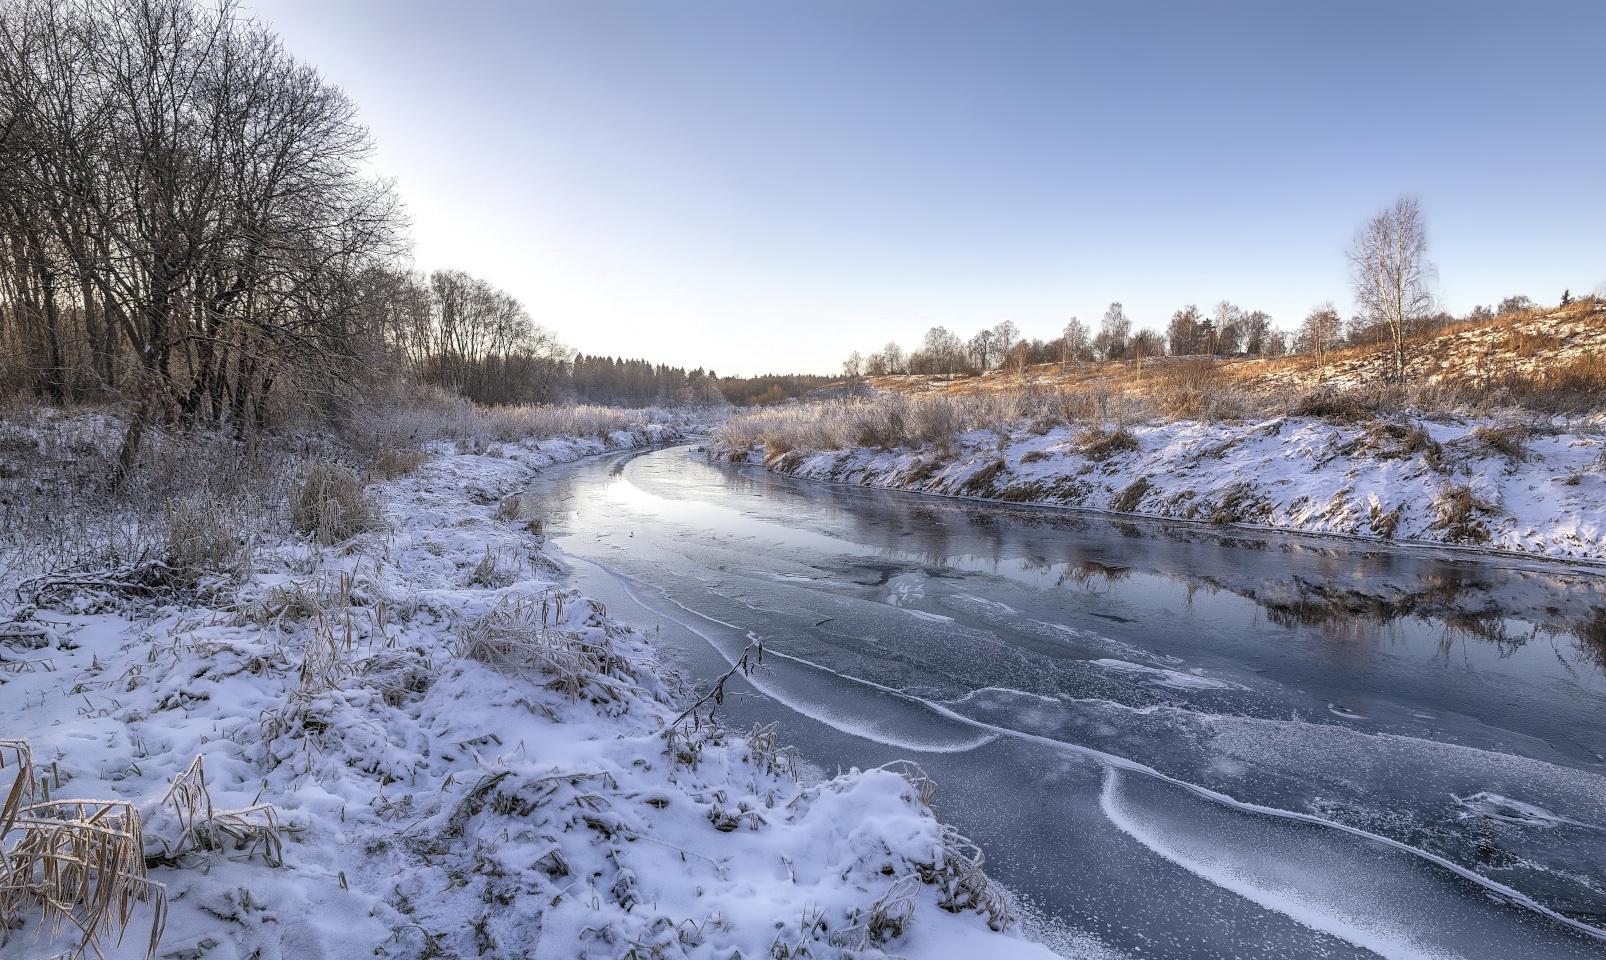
[0,0,402,483]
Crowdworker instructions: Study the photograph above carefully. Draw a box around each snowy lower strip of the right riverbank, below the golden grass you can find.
[711,417,1606,560]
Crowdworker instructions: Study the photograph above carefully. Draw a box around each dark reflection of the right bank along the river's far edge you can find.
[708,464,1606,668]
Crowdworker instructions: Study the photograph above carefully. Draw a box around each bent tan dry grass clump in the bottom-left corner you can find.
[0,740,167,960]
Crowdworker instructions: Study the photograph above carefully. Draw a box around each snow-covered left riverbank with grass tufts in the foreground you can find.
[0,433,1047,960]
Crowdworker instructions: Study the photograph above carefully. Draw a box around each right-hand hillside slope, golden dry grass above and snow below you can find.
[711,302,1606,562]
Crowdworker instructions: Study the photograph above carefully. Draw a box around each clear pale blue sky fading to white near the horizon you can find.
[246,0,1606,376]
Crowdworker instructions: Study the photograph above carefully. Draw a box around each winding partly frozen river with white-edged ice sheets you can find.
[532,446,1606,960]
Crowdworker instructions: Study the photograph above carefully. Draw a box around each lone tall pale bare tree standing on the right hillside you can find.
[1349,197,1433,380]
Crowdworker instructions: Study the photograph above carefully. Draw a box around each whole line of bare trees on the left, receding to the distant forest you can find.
[0,0,817,465]
